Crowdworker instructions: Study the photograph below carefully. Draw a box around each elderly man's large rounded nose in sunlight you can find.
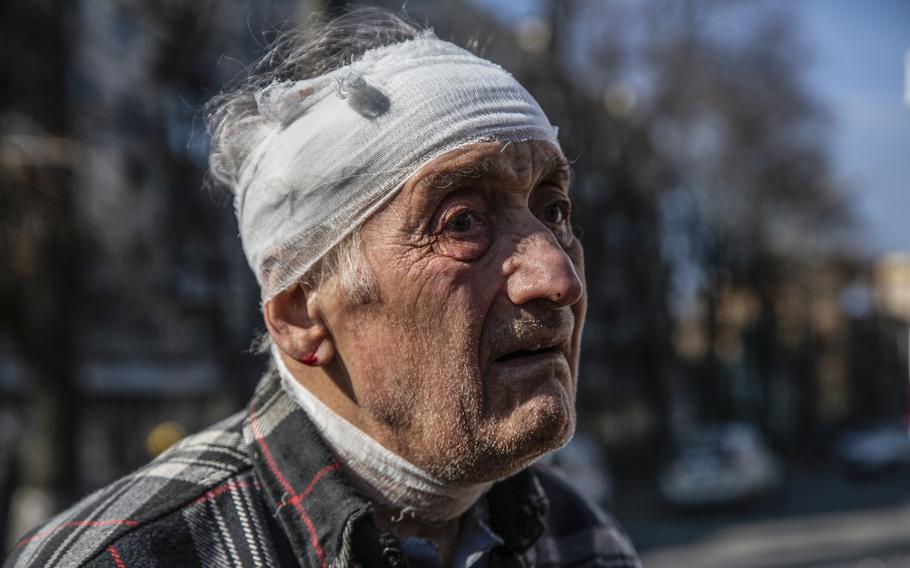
[506,222,584,307]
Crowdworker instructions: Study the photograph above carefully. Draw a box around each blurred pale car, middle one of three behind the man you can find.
[658,423,784,508]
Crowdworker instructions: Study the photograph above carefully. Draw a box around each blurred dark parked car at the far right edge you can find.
[834,419,910,475]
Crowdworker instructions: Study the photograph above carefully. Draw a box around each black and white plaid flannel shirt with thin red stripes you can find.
[4,369,640,568]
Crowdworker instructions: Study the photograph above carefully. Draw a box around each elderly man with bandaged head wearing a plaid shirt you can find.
[11,11,639,567]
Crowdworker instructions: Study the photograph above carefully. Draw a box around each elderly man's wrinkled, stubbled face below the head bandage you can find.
[325,141,585,483]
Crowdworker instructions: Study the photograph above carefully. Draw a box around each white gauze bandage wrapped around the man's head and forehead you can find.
[235,36,558,303]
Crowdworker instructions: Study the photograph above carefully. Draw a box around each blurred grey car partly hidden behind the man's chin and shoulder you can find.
[541,432,613,509]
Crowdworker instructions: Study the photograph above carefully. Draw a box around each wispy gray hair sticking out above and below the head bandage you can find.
[205,8,431,310]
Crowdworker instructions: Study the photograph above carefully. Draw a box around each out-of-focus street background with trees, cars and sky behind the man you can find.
[0,0,910,568]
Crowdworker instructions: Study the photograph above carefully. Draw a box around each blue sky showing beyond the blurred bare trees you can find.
[472,0,910,254]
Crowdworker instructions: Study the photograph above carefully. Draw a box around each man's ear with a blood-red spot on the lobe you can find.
[263,284,335,366]
